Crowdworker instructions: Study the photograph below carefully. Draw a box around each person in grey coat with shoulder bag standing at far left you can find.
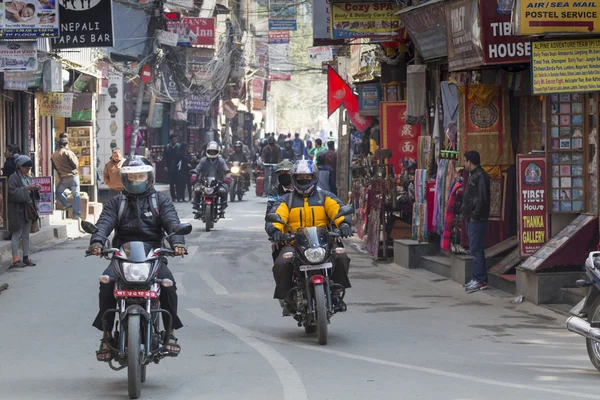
[8,155,40,268]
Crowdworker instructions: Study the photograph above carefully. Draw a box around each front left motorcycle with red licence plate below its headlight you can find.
[81,221,192,399]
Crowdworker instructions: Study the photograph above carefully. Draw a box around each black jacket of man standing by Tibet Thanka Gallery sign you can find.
[462,166,490,221]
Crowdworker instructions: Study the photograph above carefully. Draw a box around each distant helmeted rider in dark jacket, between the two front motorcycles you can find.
[194,141,231,218]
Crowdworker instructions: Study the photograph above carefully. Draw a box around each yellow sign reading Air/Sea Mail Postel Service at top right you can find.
[517,0,600,35]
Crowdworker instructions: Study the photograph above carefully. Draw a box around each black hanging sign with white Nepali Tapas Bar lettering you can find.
[52,0,115,49]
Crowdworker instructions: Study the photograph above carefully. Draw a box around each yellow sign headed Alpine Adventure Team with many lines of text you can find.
[531,39,600,94]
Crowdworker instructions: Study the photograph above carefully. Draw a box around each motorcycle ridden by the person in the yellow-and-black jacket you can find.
[265,206,354,345]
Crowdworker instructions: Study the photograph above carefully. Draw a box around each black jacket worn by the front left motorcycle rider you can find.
[90,188,185,248]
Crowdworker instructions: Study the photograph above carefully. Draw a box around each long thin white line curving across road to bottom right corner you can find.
[188,309,600,400]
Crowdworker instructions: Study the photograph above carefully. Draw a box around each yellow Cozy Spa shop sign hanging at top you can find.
[331,2,400,39]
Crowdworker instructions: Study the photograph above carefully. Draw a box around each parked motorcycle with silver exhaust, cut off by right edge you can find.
[567,251,600,371]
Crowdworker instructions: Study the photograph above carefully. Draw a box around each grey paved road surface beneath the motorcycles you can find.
[0,194,600,400]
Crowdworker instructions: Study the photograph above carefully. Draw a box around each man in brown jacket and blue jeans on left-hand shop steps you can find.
[51,138,81,219]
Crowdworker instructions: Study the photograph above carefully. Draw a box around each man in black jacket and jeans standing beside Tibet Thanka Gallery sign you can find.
[462,150,490,292]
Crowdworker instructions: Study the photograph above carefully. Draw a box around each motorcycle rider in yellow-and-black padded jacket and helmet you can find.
[265,160,352,315]
